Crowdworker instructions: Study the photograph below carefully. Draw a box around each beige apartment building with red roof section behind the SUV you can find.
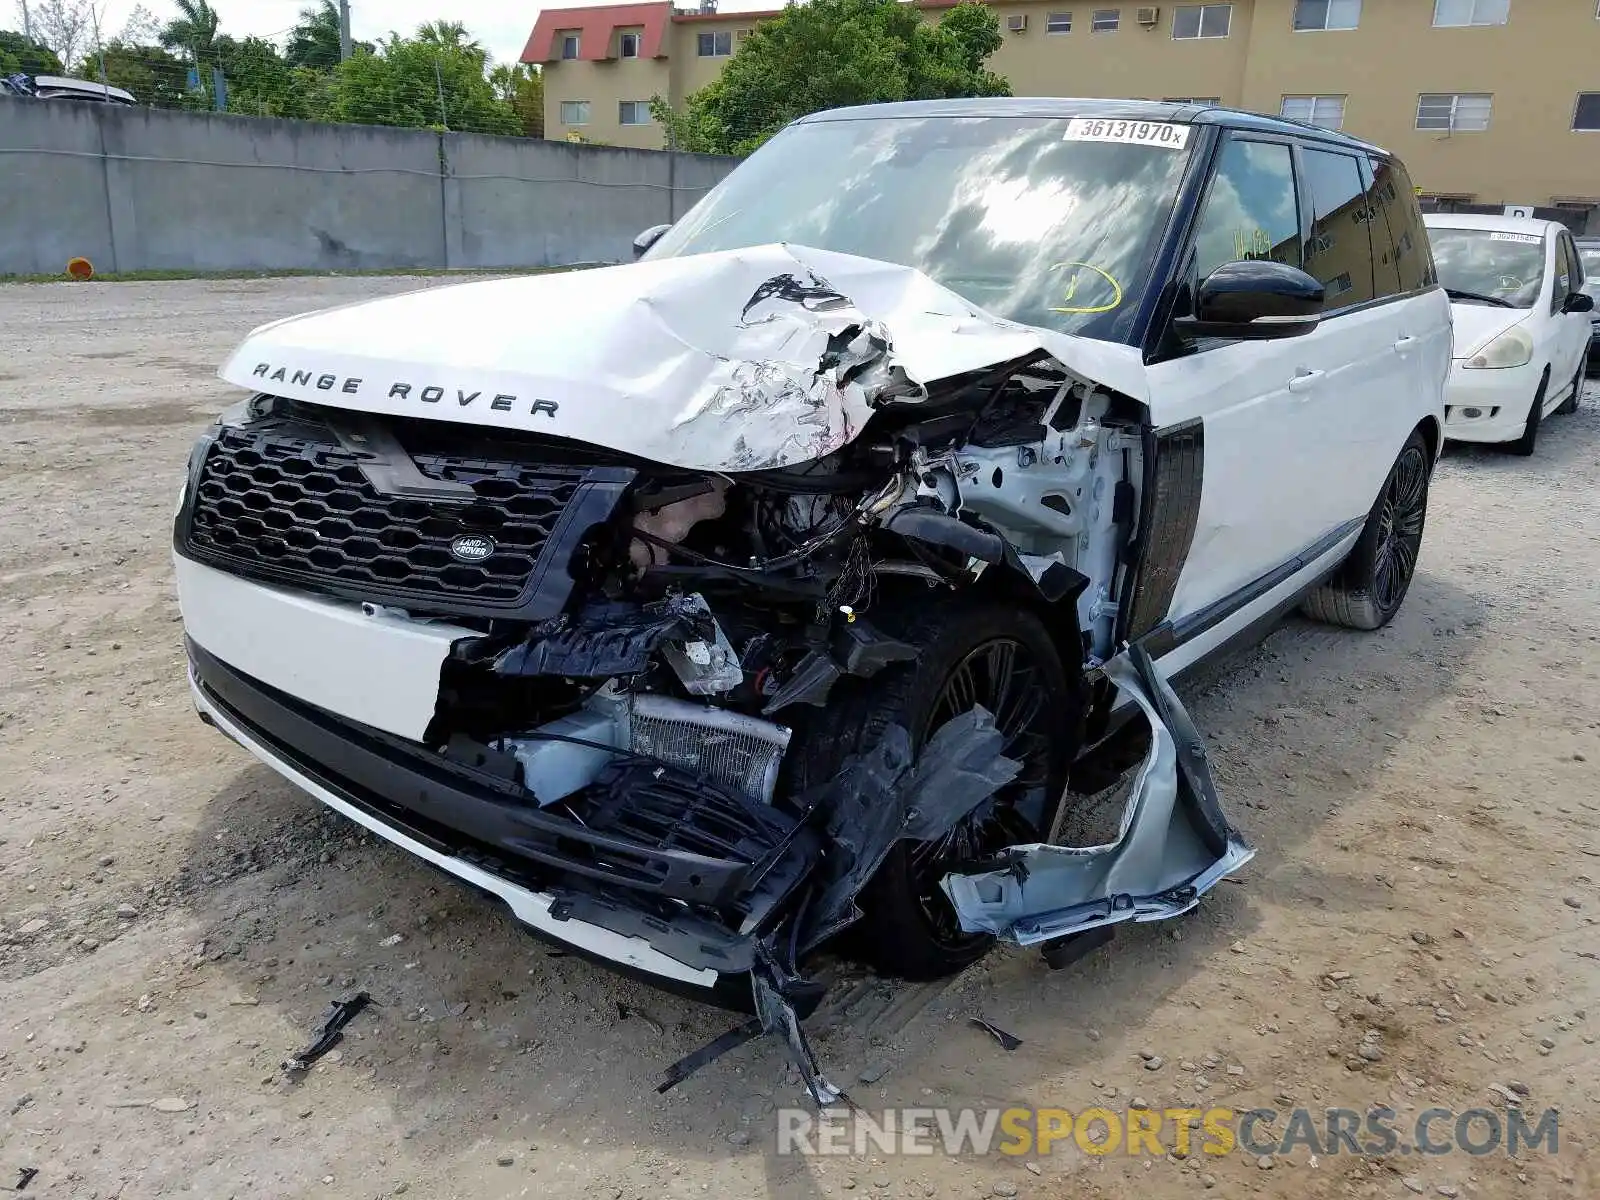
[523,0,1600,229]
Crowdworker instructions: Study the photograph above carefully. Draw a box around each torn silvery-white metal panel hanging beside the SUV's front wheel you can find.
[941,651,1256,946]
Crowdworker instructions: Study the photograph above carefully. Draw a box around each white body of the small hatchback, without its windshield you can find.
[1424,213,1590,443]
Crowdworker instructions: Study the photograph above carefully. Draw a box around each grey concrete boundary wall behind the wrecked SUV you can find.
[0,98,733,275]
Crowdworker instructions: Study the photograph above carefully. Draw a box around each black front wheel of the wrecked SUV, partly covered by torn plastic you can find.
[790,602,1085,979]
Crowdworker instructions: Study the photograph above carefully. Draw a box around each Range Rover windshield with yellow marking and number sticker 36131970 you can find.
[646,117,1192,341]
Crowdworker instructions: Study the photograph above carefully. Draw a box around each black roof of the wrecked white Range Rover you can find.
[795,96,1387,154]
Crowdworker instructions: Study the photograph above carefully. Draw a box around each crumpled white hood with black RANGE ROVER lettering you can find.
[221,245,1144,470]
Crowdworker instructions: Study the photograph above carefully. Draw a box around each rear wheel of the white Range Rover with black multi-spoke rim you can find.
[1301,430,1434,630]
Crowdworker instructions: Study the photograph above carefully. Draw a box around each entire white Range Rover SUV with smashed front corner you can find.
[174,99,1451,1081]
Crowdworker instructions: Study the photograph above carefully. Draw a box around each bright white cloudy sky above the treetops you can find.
[82,0,781,62]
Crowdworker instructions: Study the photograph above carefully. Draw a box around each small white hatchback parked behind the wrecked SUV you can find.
[1426,213,1595,454]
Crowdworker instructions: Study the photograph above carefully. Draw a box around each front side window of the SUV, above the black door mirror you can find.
[1195,139,1301,280]
